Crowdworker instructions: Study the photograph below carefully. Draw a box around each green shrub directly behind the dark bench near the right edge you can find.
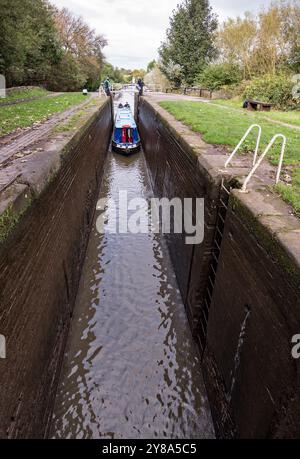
[244,74,297,109]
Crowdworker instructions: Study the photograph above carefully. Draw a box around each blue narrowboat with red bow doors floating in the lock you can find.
[112,103,141,156]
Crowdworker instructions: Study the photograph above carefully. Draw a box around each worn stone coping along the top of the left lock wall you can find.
[0,97,109,230]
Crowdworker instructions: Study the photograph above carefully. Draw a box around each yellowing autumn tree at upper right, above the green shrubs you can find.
[217,0,300,79]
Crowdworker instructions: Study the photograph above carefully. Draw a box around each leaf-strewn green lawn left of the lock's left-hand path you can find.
[0,93,88,136]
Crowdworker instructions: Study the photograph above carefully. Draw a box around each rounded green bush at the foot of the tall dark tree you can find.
[196,63,242,91]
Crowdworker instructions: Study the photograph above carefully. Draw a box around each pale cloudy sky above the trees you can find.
[51,0,271,68]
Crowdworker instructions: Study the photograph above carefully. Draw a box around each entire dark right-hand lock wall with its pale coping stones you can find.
[139,99,300,438]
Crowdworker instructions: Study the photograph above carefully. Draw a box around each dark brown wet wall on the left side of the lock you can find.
[0,101,112,438]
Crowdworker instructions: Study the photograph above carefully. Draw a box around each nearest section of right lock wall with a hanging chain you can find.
[203,191,300,438]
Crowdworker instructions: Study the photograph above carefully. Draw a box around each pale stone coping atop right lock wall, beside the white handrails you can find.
[143,96,300,288]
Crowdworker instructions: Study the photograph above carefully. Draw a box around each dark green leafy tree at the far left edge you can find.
[0,0,61,86]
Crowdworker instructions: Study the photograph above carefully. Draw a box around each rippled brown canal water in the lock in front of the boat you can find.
[51,91,214,439]
